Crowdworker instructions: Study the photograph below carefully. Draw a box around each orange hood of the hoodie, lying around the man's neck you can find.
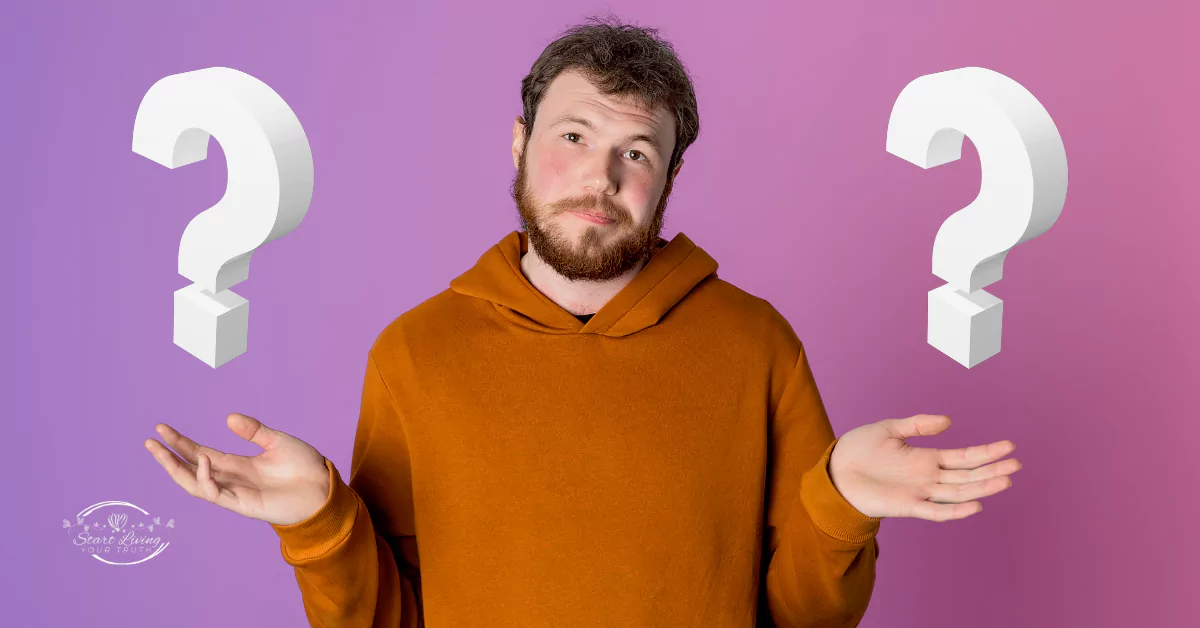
[450,229,716,336]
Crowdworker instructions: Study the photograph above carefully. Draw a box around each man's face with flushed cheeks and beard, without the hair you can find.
[512,71,683,281]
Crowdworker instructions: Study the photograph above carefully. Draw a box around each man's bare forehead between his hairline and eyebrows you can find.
[538,70,674,143]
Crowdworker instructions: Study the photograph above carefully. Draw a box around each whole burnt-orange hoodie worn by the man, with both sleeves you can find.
[271,231,880,628]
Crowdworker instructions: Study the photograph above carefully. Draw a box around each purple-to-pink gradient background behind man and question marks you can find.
[0,0,1200,628]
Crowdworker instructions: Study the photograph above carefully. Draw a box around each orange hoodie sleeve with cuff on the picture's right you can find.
[761,336,881,628]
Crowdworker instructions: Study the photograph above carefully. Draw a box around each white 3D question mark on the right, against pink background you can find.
[887,67,1067,369]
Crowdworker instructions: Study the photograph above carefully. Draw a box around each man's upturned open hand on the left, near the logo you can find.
[144,413,329,525]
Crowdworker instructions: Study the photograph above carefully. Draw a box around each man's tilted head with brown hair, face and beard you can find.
[511,18,700,281]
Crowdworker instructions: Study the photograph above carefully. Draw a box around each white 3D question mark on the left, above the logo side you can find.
[133,67,313,369]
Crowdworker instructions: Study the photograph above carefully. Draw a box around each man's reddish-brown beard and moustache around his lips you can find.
[511,142,673,281]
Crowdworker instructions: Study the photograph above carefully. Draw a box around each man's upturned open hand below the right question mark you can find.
[829,414,1021,521]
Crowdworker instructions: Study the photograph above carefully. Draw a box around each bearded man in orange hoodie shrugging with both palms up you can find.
[148,11,1019,628]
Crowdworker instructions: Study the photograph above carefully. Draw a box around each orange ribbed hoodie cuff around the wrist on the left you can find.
[271,457,359,562]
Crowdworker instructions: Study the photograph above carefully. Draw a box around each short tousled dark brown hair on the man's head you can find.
[518,13,700,177]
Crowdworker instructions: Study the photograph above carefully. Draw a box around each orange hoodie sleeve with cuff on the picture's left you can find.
[271,354,422,628]
